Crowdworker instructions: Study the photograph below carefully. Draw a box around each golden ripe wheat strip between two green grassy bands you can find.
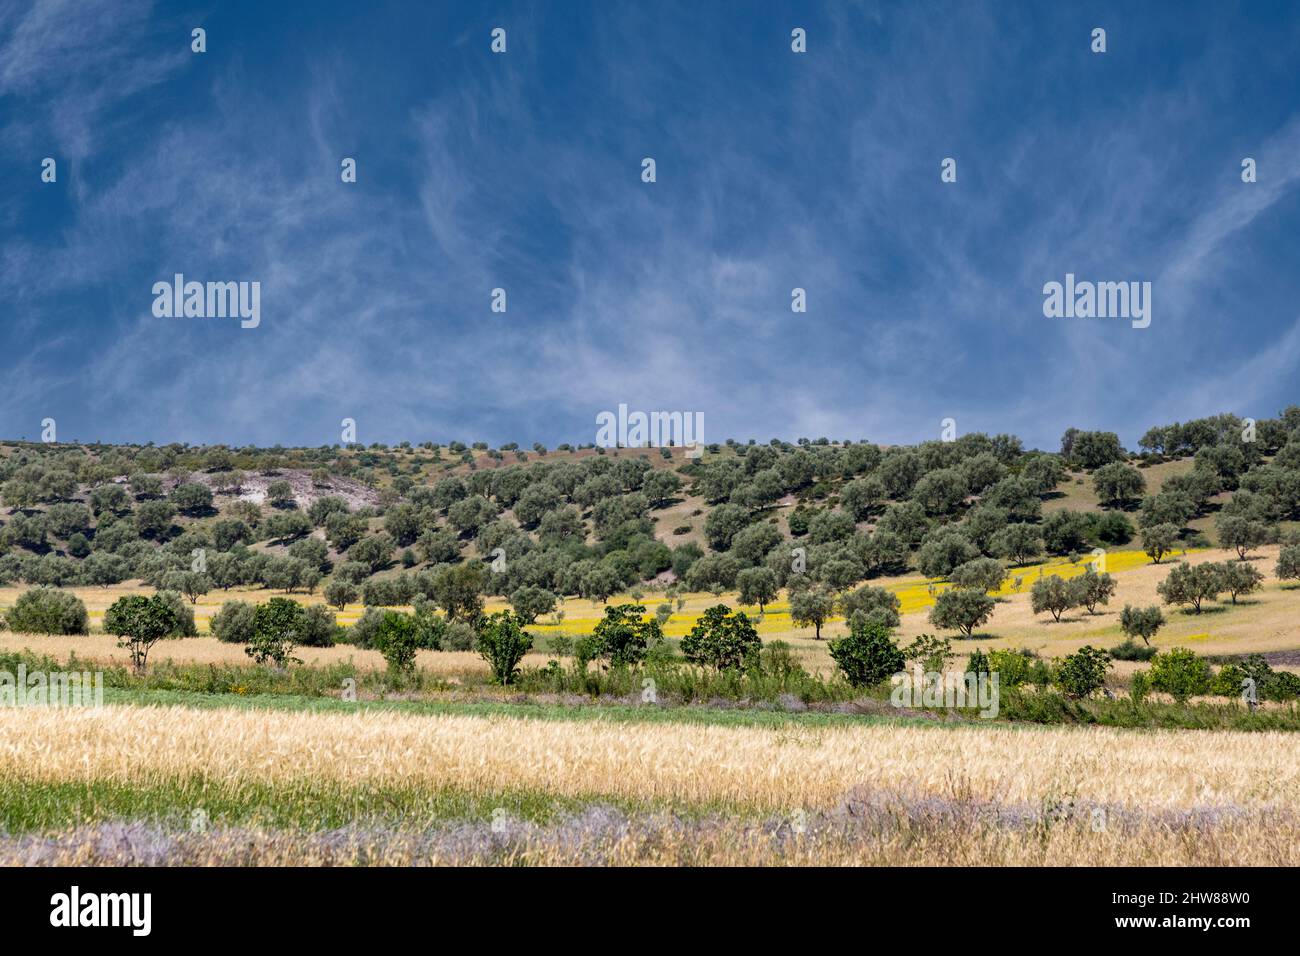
[0,706,1300,813]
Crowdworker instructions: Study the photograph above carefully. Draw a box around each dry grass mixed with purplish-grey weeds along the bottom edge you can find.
[10,800,1300,868]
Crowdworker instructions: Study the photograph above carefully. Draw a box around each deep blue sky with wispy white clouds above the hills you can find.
[0,0,1300,447]
